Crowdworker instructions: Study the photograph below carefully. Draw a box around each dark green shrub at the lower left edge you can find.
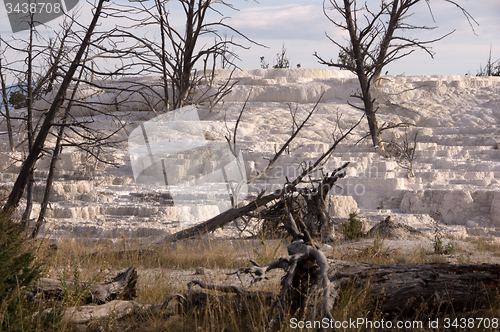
[0,210,41,331]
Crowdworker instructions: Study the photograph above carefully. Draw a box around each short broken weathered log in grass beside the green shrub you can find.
[28,267,137,304]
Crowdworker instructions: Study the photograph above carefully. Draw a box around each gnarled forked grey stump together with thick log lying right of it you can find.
[220,239,500,331]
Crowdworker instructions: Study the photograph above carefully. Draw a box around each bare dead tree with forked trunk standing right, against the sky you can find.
[314,0,477,151]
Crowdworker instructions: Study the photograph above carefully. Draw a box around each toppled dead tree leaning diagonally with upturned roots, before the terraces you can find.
[158,98,363,243]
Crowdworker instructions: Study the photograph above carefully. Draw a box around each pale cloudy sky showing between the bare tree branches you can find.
[0,0,500,75]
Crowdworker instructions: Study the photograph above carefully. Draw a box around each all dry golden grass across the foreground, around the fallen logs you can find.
[31,233,500,332]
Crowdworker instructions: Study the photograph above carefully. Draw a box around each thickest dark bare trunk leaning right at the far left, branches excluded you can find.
[3,0,107,213]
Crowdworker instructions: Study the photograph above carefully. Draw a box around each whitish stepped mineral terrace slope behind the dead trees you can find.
[0,69,500,238]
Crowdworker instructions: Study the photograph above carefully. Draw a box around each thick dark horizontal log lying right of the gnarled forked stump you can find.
[328,259,500,317]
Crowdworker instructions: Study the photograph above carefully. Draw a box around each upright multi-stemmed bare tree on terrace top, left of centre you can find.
[106,0,258,110]
